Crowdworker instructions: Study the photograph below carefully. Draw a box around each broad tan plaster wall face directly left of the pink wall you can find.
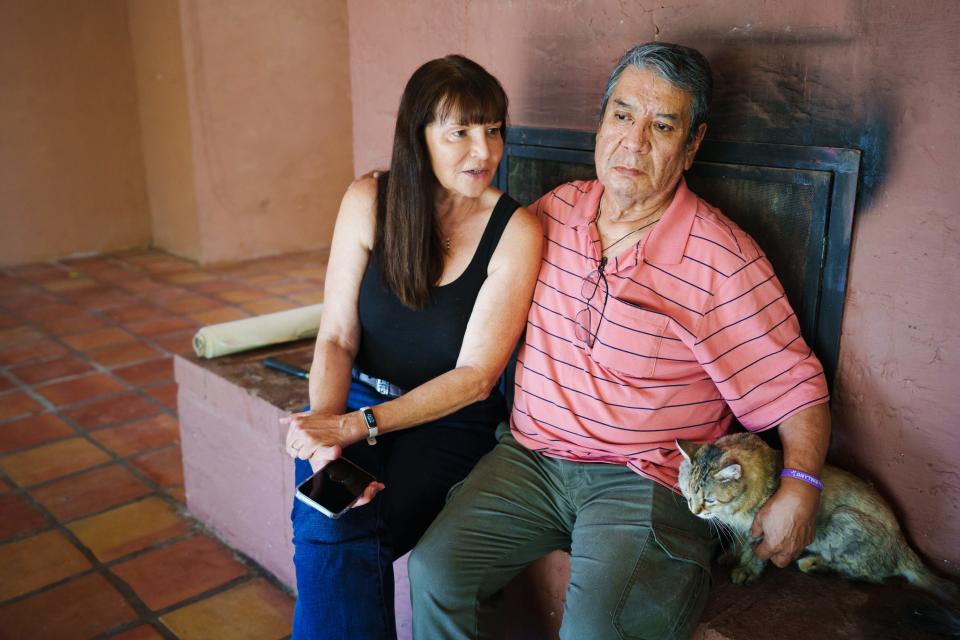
[179,0,353,263]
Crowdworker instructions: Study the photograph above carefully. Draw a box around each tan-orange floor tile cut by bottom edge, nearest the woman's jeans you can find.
[160,579,293,640]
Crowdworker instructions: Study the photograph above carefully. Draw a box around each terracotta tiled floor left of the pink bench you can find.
[0,251,325,640]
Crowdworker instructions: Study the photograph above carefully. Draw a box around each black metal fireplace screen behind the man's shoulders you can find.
[496,127,860,382]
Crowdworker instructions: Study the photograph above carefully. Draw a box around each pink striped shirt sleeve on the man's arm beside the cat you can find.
[693,255,829,431]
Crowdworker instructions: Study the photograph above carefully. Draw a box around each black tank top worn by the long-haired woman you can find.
[355,185,520,425]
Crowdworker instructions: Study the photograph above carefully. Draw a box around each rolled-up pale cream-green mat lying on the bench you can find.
[193,304,323,358]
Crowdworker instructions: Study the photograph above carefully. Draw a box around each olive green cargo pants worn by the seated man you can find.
[408,425,713,640]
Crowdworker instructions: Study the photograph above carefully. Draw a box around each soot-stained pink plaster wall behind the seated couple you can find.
[349,0,960,574]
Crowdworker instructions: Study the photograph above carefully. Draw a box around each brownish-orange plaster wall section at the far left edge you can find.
[0,0,150,265]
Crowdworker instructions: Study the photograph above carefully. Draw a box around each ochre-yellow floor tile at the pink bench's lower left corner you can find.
[67,498,190,562]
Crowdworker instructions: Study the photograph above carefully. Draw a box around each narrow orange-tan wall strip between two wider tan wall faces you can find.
[128,0,202,260]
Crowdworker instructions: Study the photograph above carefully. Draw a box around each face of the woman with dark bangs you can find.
[424,114,503,198]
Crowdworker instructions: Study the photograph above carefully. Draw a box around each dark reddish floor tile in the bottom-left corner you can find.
[0,573,137,640]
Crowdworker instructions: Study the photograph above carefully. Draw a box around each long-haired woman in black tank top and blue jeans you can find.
[286,56,542,640]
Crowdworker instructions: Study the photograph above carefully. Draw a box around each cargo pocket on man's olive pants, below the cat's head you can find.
[614,527,712,640]
